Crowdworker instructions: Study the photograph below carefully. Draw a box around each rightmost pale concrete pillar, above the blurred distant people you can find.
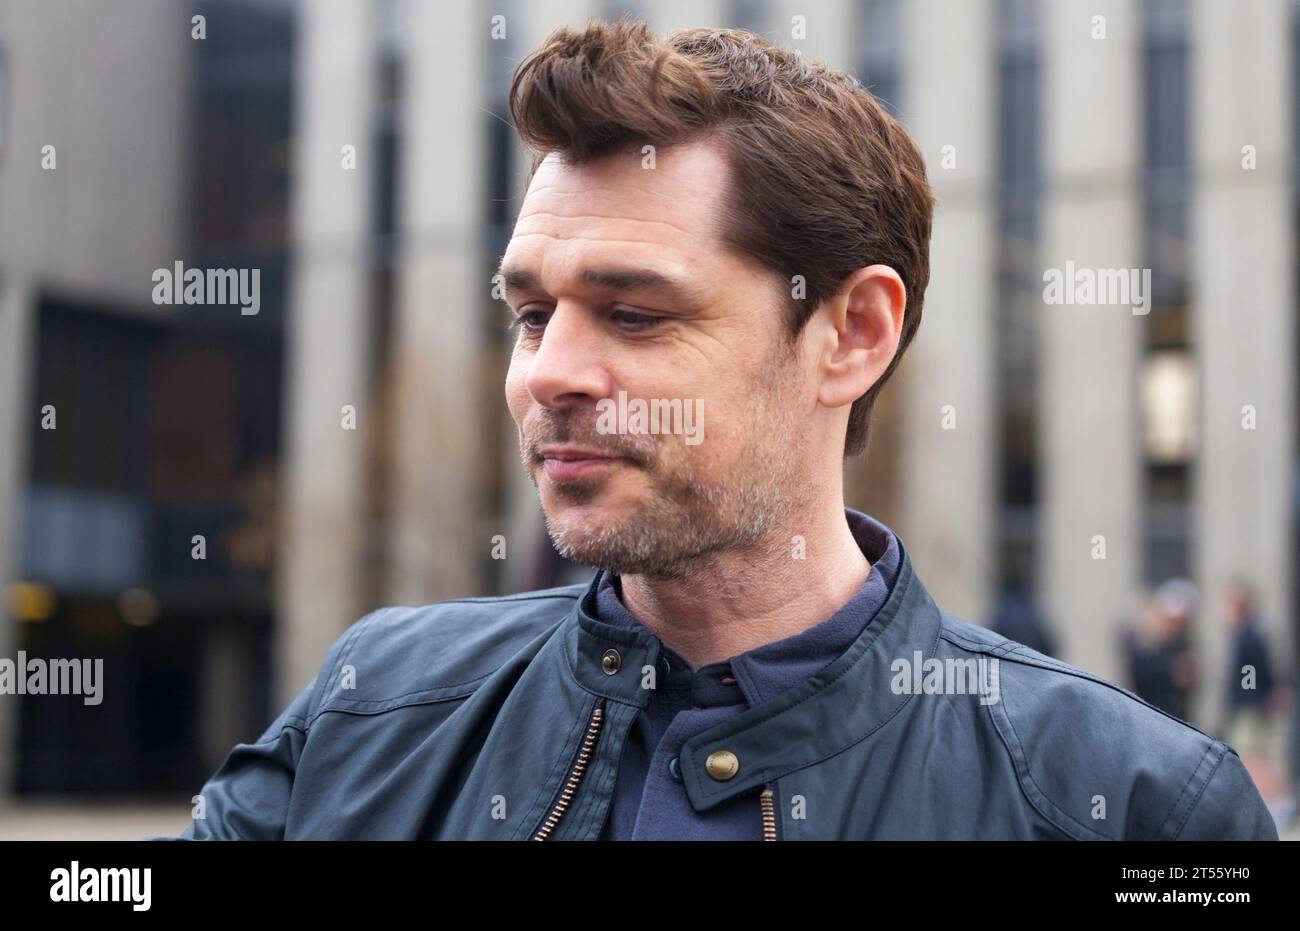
[1190,0,1296,723]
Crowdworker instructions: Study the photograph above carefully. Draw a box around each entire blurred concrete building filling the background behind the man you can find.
[0,0,1300,806]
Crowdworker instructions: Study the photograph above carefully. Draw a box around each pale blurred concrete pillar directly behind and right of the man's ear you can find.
[899,0,997,623]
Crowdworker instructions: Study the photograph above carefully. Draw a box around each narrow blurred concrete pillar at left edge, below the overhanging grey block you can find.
[0,269,36,807]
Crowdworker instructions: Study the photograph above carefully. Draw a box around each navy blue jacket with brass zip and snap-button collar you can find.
[165,535,1278,840]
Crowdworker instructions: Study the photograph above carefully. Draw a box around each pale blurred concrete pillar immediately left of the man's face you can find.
[386,3,491,603]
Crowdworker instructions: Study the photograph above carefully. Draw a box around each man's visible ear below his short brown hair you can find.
[818,265,907,408]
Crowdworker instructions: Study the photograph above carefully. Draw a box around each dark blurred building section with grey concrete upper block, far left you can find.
[0,0,294,792]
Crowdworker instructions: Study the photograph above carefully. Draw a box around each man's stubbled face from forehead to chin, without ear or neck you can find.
[502,143,816,577]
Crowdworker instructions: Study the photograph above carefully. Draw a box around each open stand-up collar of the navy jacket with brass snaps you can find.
[566,517,940,811]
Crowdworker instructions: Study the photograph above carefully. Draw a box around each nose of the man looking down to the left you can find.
[525,304,612,410]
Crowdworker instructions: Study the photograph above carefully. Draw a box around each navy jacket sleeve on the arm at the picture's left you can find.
[144,611,378,840]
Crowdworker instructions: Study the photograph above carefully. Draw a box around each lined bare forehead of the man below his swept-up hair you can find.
[506,143,729,274]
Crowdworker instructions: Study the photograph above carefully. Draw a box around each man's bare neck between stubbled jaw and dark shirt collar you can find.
[621,499,871,668]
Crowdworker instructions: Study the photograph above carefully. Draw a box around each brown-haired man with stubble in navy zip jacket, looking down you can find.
[167,22,1277,840]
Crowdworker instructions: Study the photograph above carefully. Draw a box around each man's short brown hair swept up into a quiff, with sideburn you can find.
[510,18,935,455]
